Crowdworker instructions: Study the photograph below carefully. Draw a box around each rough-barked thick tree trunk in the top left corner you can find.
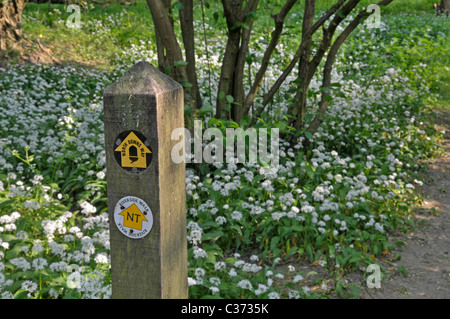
[0,0,28,51]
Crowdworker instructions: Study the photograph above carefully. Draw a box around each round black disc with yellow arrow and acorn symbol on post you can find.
[114,131,152,173]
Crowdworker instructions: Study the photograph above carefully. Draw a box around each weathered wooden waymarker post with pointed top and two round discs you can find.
[103,62,187,299]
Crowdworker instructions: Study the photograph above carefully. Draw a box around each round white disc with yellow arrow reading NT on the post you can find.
[114,196,153,239]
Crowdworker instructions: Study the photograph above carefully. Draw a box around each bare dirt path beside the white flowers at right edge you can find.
[352,111,450,299]
